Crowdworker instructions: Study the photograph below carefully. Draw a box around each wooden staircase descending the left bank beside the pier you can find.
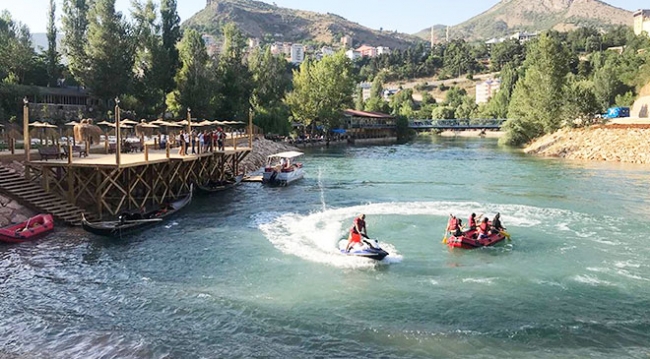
[0,166,94,226]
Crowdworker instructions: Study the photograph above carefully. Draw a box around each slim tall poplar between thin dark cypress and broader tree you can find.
[61,0,90,83]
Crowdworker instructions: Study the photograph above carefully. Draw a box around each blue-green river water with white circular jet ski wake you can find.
[0,137,650,358]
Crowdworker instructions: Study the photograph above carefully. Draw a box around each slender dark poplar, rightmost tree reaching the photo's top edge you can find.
[160,0,182,93]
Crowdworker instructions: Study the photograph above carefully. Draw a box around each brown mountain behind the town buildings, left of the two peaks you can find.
[183,0,421,48]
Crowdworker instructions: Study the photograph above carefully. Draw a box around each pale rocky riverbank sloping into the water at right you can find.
[524,124,650,164]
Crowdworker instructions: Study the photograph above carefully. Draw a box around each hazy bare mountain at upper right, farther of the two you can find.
[416,0,632,40]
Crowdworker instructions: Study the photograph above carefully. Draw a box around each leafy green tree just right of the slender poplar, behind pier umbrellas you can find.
[167,30,215,117]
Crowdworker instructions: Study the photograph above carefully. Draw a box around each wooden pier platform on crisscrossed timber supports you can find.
[26,145,251,219]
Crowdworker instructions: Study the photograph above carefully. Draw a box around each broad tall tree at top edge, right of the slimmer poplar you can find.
[81,0,133,108]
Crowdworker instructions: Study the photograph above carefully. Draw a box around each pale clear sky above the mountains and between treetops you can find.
[0,0,650,34]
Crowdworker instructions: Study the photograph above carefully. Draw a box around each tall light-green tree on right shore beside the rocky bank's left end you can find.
[501,33,569,145]
